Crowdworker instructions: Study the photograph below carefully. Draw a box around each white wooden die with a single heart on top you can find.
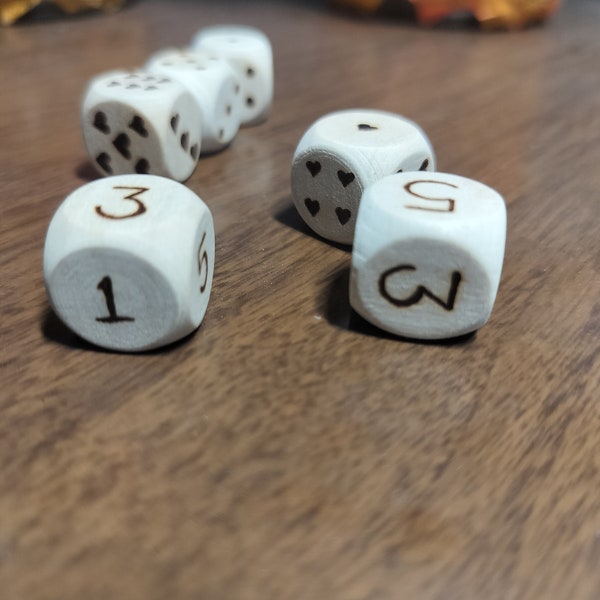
[291,110,435,244]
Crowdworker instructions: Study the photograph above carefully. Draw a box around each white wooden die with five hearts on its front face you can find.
[81,71,202,181]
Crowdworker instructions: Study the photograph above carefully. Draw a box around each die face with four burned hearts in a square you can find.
[292,150,363,244]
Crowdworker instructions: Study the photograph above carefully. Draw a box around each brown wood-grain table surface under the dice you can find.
[0,0,600,600]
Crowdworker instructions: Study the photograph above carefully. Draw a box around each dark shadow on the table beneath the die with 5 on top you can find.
[319,267,477,346]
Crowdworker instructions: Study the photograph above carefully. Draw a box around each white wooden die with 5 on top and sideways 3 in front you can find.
[350,173,506,339]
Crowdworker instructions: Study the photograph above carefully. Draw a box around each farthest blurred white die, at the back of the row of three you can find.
[192,25,273,125]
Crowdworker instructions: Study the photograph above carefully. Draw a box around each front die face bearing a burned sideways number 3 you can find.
[350,238,495,339]
